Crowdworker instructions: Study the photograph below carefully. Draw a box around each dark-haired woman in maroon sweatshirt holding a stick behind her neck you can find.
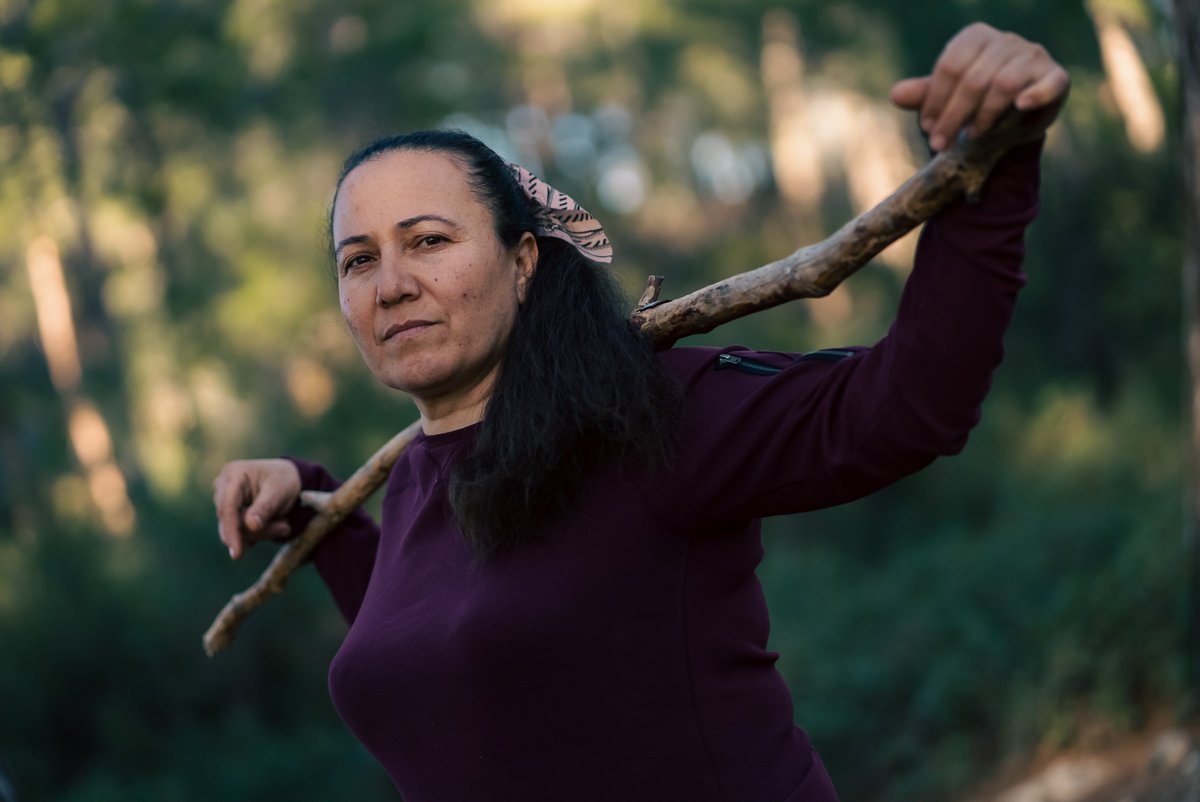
[214,25,1069,802]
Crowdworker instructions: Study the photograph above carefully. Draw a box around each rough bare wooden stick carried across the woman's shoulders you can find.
[204,109,1057,657]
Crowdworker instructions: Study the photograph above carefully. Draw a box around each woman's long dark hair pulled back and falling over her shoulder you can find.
[335,131,678,557]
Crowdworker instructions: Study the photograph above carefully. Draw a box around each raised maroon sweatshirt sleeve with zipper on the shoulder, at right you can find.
[650,142,1042,532]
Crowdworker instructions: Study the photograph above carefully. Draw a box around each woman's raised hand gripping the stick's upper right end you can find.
[892,23,1070,151]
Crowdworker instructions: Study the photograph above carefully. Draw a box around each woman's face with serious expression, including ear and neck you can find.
[332,151,538,431]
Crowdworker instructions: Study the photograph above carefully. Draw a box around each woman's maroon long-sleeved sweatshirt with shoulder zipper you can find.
[296,145,1039,802]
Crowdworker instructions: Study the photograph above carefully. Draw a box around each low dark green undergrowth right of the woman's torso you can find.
[763,381,1188,800]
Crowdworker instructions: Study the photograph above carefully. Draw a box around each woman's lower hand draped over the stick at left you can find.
[212,460,300,559]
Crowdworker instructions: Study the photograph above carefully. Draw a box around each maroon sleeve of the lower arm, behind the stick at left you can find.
[288,457,379,623]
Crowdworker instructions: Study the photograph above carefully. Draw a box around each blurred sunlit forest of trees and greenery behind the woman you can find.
[0,0,1198,802]
